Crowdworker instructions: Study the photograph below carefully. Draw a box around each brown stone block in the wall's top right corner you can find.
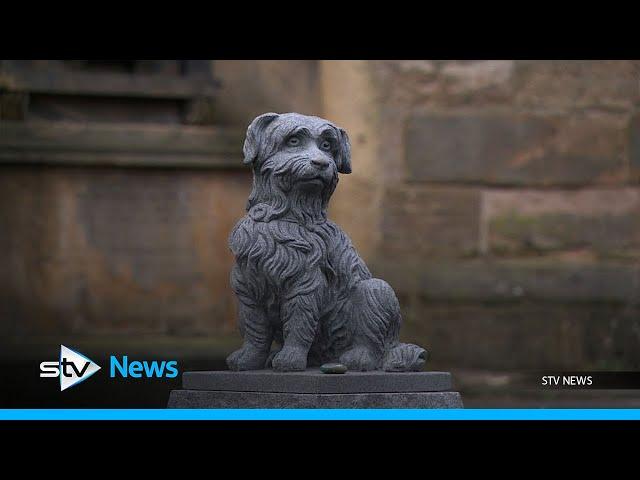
[513,60,640,110]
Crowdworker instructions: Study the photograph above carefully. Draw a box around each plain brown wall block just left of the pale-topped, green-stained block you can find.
[382,185,480,261]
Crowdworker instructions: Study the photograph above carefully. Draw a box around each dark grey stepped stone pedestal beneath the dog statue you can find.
[168,369,463,408]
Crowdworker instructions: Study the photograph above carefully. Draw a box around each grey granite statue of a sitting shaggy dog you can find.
[227,113,426,371]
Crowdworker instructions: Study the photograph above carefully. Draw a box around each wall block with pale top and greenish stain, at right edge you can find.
[482,187,640,258]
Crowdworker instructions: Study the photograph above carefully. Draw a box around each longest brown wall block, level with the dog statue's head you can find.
[406,113,628,185]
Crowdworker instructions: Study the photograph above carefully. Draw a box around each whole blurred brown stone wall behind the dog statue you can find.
[0,60,640,404]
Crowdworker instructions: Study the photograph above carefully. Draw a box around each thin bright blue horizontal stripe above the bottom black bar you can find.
[0,408,640,420]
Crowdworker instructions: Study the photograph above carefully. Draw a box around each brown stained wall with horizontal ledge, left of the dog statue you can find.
[0,61,320,348]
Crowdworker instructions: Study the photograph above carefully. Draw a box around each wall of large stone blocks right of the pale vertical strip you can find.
[325,61,640,369]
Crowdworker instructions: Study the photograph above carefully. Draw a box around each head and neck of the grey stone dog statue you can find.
[243,113,351,221]
